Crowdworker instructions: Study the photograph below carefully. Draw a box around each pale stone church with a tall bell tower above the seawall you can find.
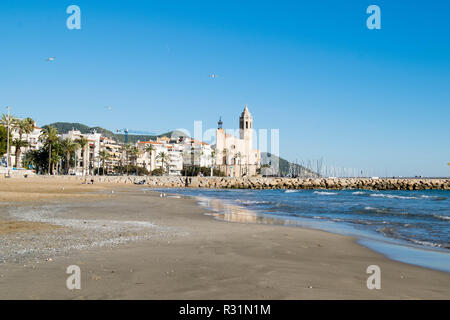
[215,105,261,177]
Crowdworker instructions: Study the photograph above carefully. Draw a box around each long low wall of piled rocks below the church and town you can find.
[39,176,450,190]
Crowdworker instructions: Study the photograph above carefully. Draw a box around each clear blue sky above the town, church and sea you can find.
[0,0,450,176]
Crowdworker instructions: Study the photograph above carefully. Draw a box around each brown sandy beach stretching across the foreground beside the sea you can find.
[0,178,450,299]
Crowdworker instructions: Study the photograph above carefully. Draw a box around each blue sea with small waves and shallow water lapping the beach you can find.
[152,189,450,272]
